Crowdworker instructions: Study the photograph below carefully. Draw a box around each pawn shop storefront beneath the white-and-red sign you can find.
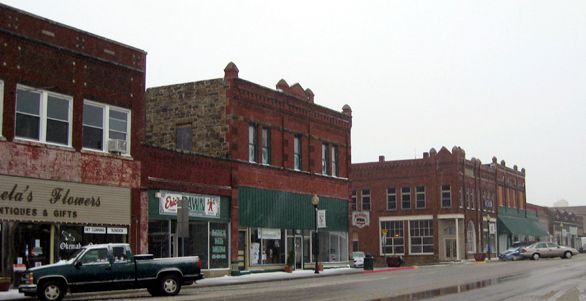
[148,190,230,271]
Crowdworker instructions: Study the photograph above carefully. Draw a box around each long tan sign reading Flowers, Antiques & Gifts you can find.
[0,175,130,225]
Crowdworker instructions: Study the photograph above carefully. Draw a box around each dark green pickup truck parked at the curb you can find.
[18,244,203,301]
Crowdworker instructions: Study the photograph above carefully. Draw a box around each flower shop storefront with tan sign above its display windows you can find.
[0,175,131,274]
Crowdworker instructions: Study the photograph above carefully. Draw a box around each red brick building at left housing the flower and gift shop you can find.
[0,4,146,275]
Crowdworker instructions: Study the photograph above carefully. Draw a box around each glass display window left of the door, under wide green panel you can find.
[250,228,285,265]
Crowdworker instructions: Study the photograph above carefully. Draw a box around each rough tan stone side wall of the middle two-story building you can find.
[145,79,228,157]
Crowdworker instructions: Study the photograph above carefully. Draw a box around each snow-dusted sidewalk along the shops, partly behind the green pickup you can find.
[0,266,417,301]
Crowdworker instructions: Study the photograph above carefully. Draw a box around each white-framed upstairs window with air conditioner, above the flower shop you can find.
[83,100,130,154]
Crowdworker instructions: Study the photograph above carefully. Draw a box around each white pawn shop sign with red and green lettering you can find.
[159,191,220,218]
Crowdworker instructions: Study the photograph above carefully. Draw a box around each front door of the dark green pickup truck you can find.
[69,247,112,291]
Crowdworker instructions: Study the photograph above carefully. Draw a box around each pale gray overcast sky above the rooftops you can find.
[5,0,586,206]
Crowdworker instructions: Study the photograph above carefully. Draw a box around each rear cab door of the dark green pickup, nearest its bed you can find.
[112,245,136,288]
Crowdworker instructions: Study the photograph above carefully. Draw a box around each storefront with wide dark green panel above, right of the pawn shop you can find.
[238,187,348,271]
